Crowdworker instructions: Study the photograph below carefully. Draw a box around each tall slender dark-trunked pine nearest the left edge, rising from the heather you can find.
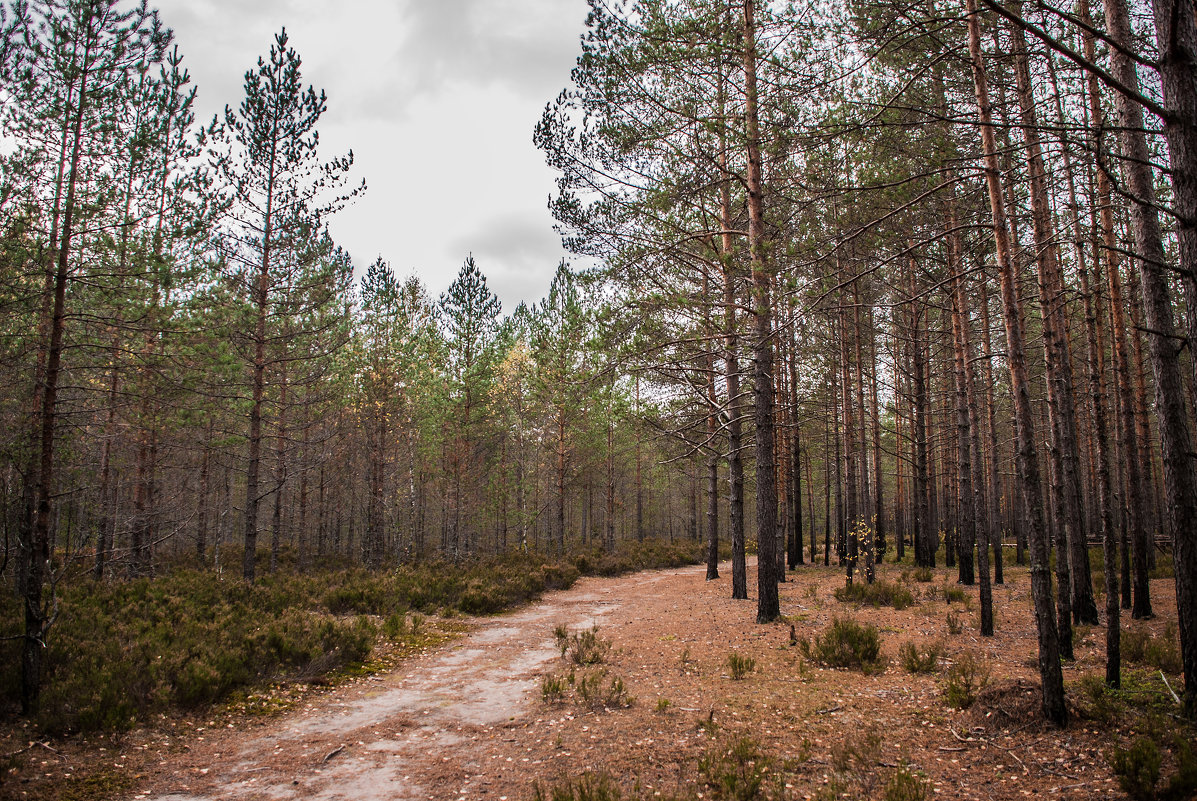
[2,0,170,714]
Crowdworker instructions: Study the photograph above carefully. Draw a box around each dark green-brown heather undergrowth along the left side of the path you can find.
[0,541,705,735]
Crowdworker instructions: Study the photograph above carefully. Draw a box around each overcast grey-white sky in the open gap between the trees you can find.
[153,0,587,312]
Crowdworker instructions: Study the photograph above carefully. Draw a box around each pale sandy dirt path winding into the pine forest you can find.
[135,555,705,801]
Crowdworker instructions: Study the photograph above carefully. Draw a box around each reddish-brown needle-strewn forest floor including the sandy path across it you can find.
[0,553,1193,801]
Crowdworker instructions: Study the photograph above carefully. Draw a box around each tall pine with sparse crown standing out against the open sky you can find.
[208,29,365,581]
